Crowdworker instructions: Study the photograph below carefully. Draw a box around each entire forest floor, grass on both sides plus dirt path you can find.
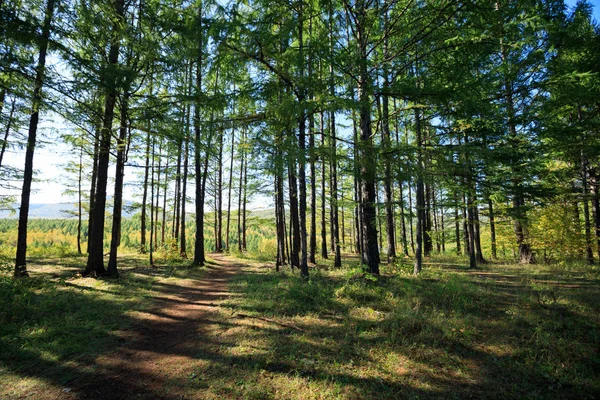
[0,254,600,400]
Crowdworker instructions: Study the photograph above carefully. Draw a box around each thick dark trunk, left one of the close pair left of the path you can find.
[84,0,125,275]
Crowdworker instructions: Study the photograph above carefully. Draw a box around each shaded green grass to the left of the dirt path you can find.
[0,255,207,399]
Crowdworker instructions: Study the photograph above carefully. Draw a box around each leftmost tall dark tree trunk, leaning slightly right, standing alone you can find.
[14,0,54,278]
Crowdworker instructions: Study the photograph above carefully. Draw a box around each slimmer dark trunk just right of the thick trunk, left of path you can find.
[106,91,129,278]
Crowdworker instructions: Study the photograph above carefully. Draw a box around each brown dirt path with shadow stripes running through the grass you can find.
[65,254,243,400]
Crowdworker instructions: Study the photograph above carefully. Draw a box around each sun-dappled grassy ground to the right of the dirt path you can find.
[203,255,600,399]
